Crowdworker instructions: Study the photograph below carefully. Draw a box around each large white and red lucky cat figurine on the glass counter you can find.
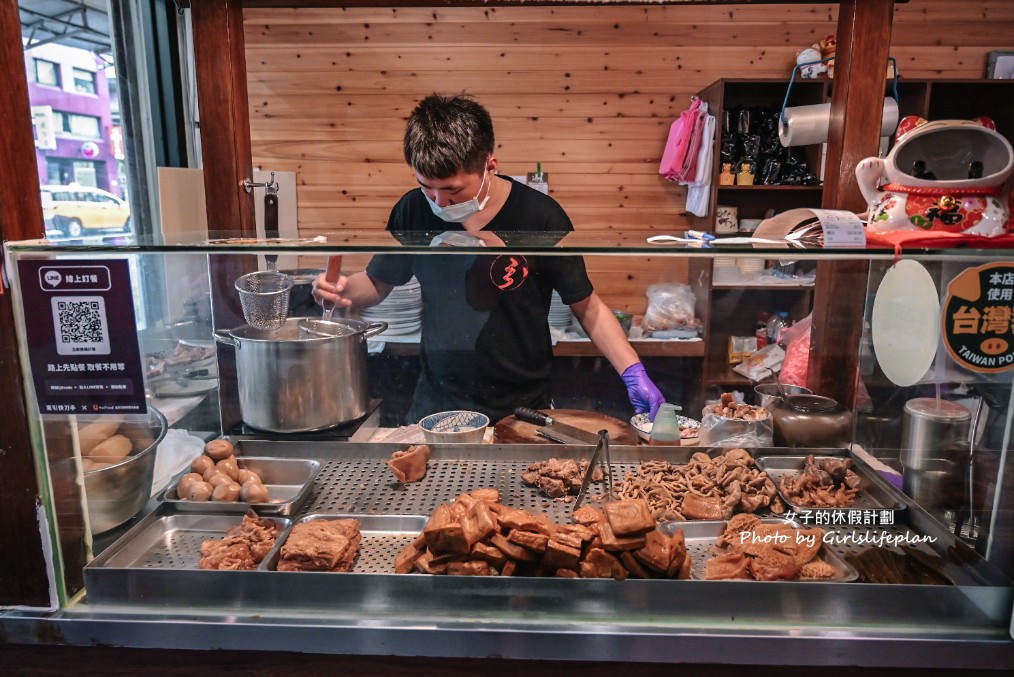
[856,116,1014,237]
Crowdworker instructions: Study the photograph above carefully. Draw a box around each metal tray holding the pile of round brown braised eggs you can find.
[158,457,320,515]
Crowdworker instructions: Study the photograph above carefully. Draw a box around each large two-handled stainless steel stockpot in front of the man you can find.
[215,317,387,433]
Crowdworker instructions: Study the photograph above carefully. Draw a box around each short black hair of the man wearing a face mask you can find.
[405,94,494,178]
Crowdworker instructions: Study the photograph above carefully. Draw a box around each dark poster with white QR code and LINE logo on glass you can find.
[17,259,148,413]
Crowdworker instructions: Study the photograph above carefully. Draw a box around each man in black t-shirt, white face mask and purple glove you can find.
[313,95,663,422]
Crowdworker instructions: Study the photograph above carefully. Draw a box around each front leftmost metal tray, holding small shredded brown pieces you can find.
[85,512,292,571]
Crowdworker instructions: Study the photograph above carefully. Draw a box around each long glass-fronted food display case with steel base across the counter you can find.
[0,232,1014,668]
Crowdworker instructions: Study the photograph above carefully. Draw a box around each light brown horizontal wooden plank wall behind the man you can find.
[243,0,1014,311]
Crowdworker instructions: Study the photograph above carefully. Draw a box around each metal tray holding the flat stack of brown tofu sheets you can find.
[259,514,428,577]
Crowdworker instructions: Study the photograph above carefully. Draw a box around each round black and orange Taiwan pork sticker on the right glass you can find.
[943,262,1014,373]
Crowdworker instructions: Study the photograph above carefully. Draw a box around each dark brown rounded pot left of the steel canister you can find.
[768,395,853,448]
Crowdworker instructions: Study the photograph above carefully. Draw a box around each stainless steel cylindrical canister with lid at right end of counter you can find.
[900,397,971,470]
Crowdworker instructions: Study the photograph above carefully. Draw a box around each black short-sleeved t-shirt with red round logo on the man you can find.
[366,179,593,423]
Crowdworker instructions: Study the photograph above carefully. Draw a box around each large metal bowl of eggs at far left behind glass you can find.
[79,407,168,534]
